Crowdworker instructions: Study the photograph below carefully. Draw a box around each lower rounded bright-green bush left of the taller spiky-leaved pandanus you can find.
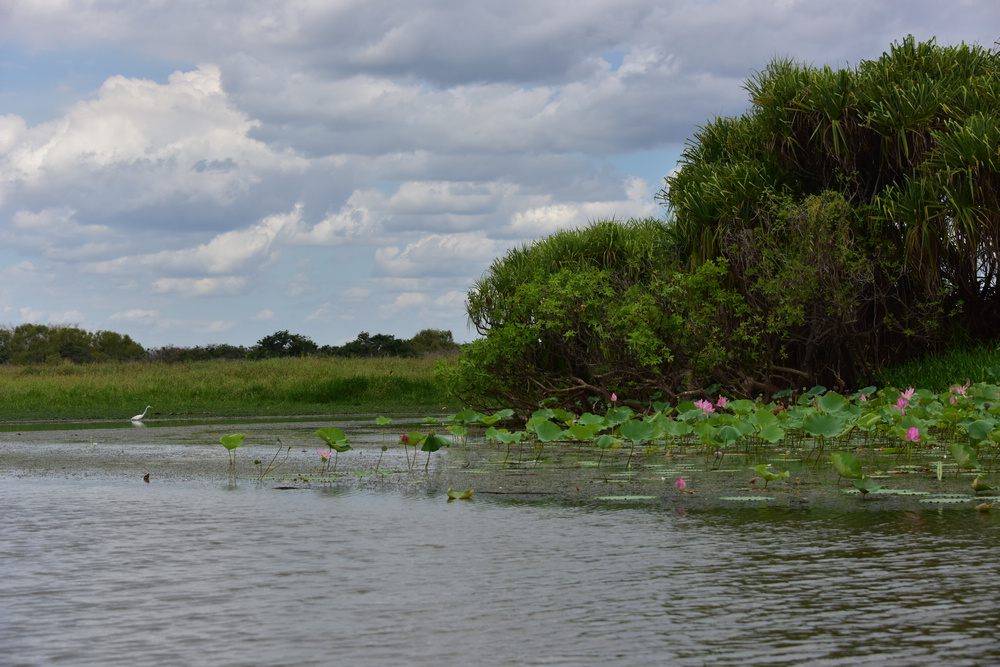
[441,220,742,409]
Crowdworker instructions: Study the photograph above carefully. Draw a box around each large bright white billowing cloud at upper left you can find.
[0,65,307,217]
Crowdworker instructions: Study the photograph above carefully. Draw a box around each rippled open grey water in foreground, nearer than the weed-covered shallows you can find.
[0,478,1000,665]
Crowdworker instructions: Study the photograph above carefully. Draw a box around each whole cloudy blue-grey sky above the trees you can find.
[0,0,1000,348]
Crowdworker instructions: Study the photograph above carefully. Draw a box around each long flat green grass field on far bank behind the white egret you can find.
[0,357,459,421]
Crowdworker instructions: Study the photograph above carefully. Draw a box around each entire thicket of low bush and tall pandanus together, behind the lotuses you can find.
[448,37,1000,412]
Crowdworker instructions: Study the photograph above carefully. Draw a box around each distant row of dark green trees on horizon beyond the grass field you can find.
[0,324,460,365]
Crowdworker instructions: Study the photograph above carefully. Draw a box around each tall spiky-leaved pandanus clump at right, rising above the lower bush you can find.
[661,37,1000,391]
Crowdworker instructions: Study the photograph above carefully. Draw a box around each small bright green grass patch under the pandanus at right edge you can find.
[875,342,1000,391]
